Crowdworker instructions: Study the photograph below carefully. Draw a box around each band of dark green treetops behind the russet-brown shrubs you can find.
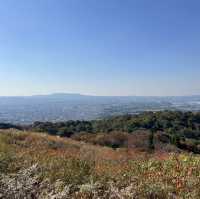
[32,111,200,136]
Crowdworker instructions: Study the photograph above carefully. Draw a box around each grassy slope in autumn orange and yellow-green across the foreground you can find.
[0,130,200,199]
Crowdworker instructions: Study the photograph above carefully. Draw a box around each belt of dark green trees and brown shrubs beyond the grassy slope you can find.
[29,111,200,153]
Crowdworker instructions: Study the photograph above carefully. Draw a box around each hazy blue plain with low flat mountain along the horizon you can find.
[0,93,200,124]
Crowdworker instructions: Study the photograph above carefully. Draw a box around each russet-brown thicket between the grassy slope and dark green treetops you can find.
[71,129,181,153]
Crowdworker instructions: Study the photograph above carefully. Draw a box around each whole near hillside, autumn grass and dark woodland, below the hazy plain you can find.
[0,111,200,199]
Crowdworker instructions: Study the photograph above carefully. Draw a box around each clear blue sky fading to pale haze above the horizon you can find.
[0,0,200,95]
